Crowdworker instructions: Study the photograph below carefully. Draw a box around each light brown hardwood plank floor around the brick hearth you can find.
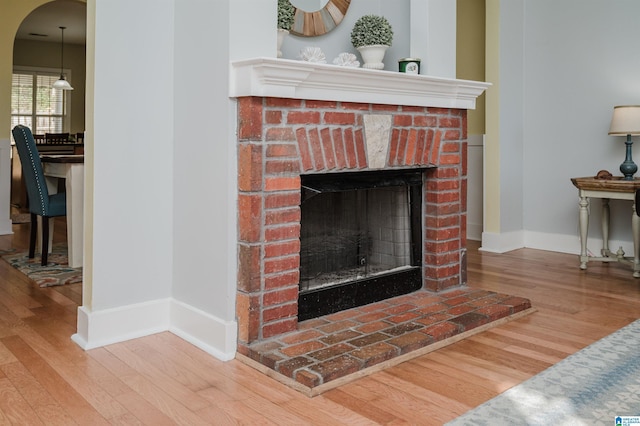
[0,224,640,425]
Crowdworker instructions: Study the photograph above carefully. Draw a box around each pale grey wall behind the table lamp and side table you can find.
[524,0,640,253]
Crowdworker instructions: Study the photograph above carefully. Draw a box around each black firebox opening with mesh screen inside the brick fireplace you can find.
[298,169,424,321]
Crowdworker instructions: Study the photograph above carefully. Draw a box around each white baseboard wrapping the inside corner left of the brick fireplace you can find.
[71,299,237,361]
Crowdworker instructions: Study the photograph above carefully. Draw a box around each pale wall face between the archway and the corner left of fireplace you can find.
[92,0,173,310]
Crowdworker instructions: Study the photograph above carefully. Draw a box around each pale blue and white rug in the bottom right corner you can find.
[447,320,640,426]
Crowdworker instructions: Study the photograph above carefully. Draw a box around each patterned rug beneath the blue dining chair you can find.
[0,244,82,287]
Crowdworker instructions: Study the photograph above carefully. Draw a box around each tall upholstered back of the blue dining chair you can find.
[11,125,50,216]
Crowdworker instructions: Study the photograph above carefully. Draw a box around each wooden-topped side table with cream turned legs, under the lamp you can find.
[571,176,640,278]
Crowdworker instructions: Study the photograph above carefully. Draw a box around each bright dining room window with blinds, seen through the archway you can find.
[11,69,68,134]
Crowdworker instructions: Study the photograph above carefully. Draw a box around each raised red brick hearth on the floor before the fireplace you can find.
[240,287,531,396]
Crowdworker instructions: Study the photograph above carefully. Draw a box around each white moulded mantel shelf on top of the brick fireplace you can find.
[229,58,491,109]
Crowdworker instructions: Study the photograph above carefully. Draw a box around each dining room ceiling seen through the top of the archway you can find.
[16,0,87,44]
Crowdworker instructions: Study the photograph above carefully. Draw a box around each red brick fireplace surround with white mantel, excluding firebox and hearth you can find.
[232,59,486,353]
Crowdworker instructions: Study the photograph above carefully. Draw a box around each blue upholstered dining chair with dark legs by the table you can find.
[12,125,67,266]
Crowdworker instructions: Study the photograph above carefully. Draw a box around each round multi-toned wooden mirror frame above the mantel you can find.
[289,0,351,37]
